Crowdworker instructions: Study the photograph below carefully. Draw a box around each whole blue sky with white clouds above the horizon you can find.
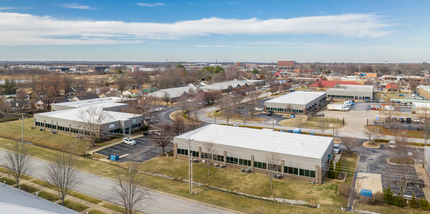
[0,0,430,63]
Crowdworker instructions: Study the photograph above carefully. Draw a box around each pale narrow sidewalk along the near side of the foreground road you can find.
[0,172,120,214]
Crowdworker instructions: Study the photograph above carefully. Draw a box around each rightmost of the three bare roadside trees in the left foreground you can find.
[112,162,153,214]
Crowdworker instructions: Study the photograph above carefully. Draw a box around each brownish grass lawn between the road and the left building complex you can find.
[0,118,117,155]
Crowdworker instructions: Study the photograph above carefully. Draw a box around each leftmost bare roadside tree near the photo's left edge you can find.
[5,142,33,187]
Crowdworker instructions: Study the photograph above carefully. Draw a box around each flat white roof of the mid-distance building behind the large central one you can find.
[264,91,325,105]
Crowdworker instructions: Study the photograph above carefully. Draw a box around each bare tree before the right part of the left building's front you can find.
[78,106,111,147]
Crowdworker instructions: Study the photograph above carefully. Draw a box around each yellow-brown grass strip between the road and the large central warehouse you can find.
[141,157,346,207]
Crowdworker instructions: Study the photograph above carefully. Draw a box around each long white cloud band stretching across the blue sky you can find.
[0,12,392,45]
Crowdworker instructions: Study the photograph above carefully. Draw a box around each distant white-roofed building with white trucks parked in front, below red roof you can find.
[327,85,374,100]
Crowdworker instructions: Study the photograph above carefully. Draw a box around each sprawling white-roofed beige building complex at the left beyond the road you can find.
[34,98,143,137]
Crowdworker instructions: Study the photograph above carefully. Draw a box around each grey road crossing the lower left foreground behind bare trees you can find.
[0,150,232,214]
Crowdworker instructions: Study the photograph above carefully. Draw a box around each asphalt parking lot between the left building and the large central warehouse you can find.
[97,137,173,162]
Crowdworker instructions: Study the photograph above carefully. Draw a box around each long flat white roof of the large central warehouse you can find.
[175,124,333,159]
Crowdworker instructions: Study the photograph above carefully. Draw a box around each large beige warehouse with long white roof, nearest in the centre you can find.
[173,124,333,183]
